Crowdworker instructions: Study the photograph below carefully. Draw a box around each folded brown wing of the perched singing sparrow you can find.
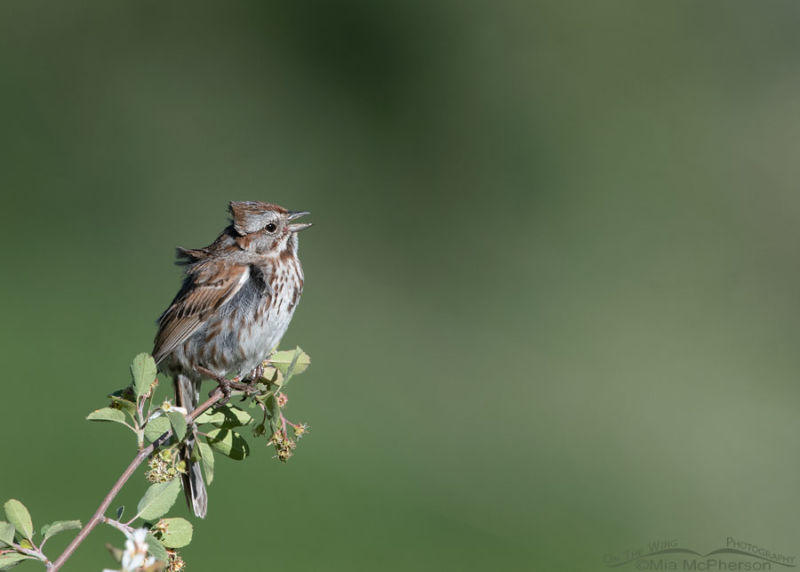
[153,260,250,363]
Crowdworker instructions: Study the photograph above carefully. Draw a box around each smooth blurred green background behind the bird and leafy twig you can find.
[0,0,800,571]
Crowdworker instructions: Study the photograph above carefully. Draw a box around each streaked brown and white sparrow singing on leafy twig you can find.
[153,202,311,518]
